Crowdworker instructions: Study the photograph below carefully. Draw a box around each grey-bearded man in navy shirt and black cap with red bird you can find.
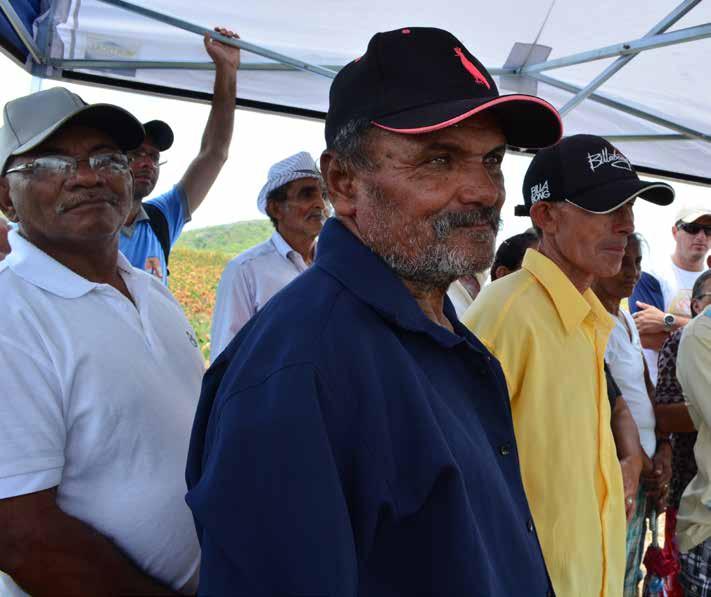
[187,28,561,597]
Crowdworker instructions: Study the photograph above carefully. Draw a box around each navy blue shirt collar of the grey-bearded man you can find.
[315,218,485,352]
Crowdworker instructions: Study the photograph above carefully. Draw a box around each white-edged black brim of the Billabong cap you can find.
[566,179,674,214]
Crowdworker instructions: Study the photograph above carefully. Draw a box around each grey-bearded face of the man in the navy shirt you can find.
[354,115,506,288]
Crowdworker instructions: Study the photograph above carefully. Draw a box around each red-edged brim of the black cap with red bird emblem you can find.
[373,94,563,149]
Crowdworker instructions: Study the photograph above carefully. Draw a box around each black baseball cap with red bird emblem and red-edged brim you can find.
[326,27,563,148]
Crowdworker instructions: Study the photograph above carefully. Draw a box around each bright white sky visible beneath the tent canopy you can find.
[0,54,711,268]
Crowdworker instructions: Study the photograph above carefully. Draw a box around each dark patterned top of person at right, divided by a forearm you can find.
[654,328,696,510]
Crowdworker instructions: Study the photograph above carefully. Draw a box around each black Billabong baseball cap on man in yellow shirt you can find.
[515,135,674,216]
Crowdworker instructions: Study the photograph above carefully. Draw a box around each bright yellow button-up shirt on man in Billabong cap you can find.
[463,249,626,597]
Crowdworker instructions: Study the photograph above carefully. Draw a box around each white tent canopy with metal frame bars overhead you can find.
[0,0,711,184]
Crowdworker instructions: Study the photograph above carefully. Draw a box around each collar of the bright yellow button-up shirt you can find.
[521,244,615,333]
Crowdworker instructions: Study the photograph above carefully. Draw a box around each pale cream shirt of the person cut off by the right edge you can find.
[676,306,711,552]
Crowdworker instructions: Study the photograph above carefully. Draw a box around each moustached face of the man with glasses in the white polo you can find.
[0,125,133,248]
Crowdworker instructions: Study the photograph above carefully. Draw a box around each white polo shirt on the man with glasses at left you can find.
[0,231,204,590]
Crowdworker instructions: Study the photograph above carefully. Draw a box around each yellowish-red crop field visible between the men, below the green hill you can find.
[170,246,232,361]
